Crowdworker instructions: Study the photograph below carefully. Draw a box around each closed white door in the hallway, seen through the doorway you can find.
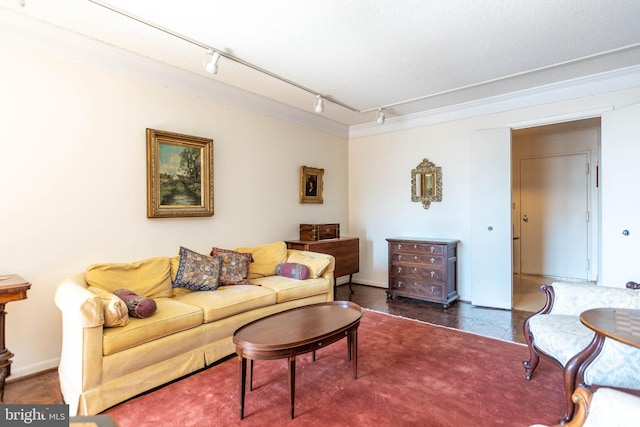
[520,153,589,280]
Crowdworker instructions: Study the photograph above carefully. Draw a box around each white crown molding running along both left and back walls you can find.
[6,8,640,139]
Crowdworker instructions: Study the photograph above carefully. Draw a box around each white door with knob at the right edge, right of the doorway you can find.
[598,104,640,287]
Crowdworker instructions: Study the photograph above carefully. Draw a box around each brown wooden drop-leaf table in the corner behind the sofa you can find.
[285,237,360,292]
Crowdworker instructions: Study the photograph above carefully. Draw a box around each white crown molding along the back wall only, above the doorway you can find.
[349,65,640,139]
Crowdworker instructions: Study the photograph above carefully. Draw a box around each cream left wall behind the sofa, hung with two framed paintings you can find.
[0,36,348,378]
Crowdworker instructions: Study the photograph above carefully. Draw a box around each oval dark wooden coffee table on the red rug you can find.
[233,301,362,419]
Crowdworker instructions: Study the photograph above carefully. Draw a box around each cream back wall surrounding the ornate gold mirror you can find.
[349,89,640,301]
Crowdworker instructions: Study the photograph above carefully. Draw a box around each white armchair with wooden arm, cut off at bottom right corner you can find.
[531,387,640,427]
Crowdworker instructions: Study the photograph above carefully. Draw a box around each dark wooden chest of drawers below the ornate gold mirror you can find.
[387,237,459,308]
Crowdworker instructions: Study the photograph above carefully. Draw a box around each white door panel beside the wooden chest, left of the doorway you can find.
[468,128,512,310]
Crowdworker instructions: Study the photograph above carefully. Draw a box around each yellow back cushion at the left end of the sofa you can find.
[85,257,171,298]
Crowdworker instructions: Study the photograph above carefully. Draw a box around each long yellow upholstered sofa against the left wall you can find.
[55,242,335,416]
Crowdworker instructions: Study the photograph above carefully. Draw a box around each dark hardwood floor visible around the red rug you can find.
[4,284,531,404]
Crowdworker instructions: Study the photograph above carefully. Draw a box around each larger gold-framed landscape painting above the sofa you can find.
[147,128,213,218]
